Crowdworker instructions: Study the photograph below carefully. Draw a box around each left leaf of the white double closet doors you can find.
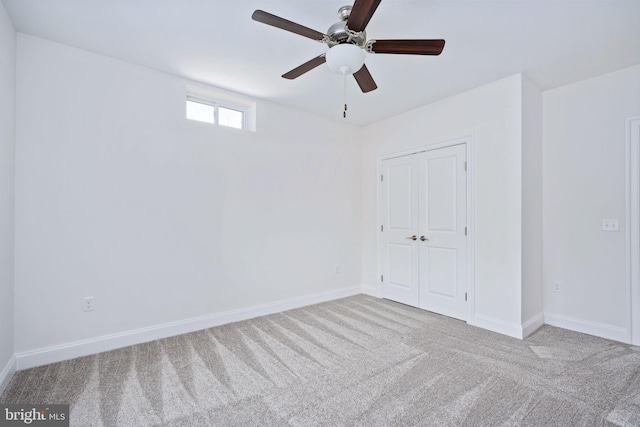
[381,156,420,307]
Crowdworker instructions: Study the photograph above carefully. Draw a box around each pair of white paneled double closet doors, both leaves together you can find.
[380,144,467,320]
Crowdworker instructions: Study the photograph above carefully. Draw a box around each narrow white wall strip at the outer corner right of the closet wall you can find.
[522,76,544,328]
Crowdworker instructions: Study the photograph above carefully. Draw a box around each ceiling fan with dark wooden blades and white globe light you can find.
[251,0,444,93]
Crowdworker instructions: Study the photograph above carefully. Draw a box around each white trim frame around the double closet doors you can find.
[376,135,476,325]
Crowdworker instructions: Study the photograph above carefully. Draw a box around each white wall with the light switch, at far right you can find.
[543,66,640,341]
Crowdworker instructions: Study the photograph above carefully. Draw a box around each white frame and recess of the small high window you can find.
[185,83,256,132]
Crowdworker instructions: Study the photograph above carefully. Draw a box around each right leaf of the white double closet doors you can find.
[419,145,467,320]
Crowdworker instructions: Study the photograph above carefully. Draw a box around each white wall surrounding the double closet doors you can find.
[362,75,523,336]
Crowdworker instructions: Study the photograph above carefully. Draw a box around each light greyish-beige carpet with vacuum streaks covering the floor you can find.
[0,295,640,426]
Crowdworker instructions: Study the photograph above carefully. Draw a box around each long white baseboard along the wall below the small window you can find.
[14,286,362,371]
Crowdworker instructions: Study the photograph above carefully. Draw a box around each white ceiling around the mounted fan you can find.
[2,0,640,125]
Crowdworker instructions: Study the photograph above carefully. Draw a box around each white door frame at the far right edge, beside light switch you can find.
[625,116,640,345]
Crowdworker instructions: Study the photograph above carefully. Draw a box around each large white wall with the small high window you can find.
[15,34,361,366]
